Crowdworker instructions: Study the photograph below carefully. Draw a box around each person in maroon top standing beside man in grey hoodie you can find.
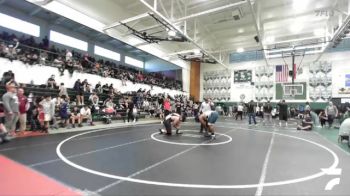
[17,88,29,133]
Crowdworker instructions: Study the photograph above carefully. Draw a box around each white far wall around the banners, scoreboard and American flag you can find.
[200,52,350,102]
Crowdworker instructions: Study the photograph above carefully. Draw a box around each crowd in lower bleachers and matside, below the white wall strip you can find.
[0,68,193,138]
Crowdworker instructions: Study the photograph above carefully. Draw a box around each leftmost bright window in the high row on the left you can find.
[0,13,40,37]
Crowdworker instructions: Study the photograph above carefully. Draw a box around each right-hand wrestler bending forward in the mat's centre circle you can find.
[199,110,219,139]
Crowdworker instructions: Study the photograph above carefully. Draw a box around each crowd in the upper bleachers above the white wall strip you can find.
[0,32,182,90]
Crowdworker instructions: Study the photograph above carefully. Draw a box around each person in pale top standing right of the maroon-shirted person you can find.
[40,95,55,133]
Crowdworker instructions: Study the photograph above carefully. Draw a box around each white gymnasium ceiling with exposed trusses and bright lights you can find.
[23,0,349,66]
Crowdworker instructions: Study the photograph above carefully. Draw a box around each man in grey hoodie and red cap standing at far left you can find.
[2,81,19,135]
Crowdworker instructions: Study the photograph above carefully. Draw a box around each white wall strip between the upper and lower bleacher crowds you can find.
[0,58,188,96]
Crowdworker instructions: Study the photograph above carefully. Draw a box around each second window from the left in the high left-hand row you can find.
[50,30,88,51]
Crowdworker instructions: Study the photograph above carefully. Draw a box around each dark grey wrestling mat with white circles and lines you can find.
[0,118,350,196]
